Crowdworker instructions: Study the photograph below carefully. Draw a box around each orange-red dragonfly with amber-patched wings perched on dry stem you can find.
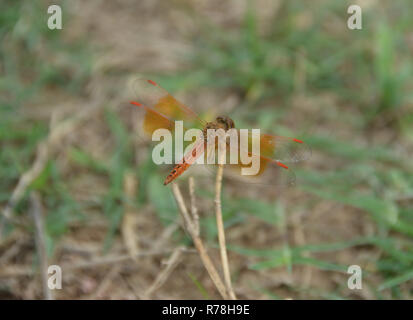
[130,78,311,185]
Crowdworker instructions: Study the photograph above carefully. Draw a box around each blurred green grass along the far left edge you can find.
[0,1,92,249]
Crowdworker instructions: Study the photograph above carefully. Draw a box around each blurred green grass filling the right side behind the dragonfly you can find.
[165,1,413,298]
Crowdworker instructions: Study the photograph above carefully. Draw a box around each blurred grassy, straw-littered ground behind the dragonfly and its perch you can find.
[0,0,413,299]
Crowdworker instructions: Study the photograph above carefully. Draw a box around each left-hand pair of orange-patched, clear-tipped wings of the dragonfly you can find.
[131,79,205,136]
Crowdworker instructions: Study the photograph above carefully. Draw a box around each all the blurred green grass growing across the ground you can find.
[0,0,413,299]
